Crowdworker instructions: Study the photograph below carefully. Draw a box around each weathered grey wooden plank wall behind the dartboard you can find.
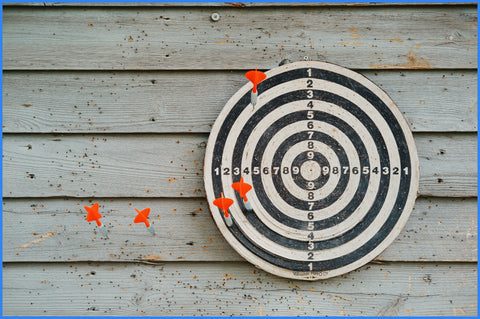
[3,4,477,316]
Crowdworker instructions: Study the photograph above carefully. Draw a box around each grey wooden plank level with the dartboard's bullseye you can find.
[3,133,477,197]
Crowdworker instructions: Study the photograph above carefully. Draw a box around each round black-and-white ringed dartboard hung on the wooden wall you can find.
[204,61,419,280]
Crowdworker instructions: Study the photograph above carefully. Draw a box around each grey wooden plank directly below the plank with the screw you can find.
[3,70,477,133]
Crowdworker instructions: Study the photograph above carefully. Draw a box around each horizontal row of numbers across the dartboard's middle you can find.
[214,166,409,176]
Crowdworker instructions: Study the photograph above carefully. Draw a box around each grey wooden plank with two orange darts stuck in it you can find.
[3,197,477,262]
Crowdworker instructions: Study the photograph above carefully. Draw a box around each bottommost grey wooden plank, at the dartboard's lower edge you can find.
[3,263,477,316]
